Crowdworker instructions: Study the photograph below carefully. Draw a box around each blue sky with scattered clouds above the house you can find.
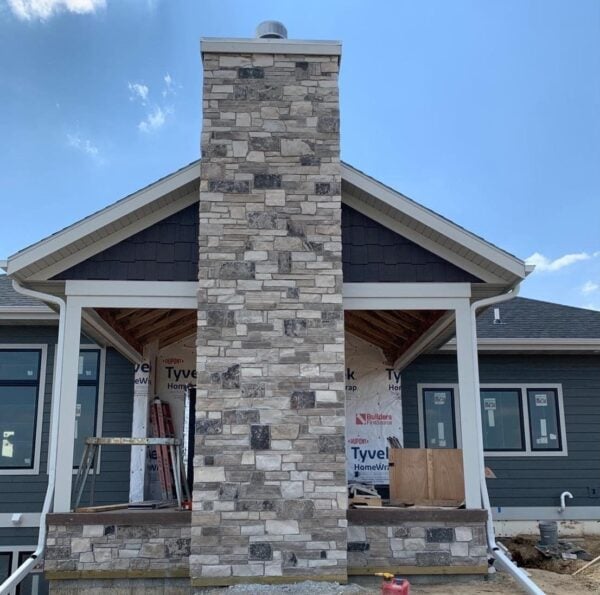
[0,0,600,309]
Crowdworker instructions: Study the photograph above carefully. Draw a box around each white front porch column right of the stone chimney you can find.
[456,299,481,508]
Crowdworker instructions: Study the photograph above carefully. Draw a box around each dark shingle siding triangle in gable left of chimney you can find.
[54,204,199,281]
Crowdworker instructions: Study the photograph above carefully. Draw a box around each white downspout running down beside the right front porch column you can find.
[471,285,545,595]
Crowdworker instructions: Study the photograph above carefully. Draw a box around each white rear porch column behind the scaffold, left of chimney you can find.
[129,341,158,502]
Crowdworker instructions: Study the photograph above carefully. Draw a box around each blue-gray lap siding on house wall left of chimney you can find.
[0,326,133,528]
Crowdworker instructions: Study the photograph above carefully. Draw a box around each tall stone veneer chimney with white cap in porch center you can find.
[190,39,347,586]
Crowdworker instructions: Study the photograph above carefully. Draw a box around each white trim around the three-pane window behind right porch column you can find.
[417,382,569,458]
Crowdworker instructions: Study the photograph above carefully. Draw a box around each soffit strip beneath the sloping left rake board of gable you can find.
[27,192,199,281]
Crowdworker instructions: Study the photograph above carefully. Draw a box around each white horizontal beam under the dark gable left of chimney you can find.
[65,281,198,298]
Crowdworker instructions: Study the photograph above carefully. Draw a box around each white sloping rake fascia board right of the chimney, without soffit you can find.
[342,163,527,279]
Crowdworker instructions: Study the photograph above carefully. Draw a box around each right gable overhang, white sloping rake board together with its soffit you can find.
[342,163,527,285]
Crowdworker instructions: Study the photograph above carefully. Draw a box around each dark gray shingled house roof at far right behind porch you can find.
[477,297,600,339]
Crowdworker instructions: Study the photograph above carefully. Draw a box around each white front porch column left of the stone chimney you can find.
[54,297,81,512]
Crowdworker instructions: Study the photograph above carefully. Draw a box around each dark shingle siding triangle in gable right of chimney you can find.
[342,205,480,283]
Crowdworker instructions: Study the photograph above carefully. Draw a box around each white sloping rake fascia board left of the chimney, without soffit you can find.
[8,161,200,275]
